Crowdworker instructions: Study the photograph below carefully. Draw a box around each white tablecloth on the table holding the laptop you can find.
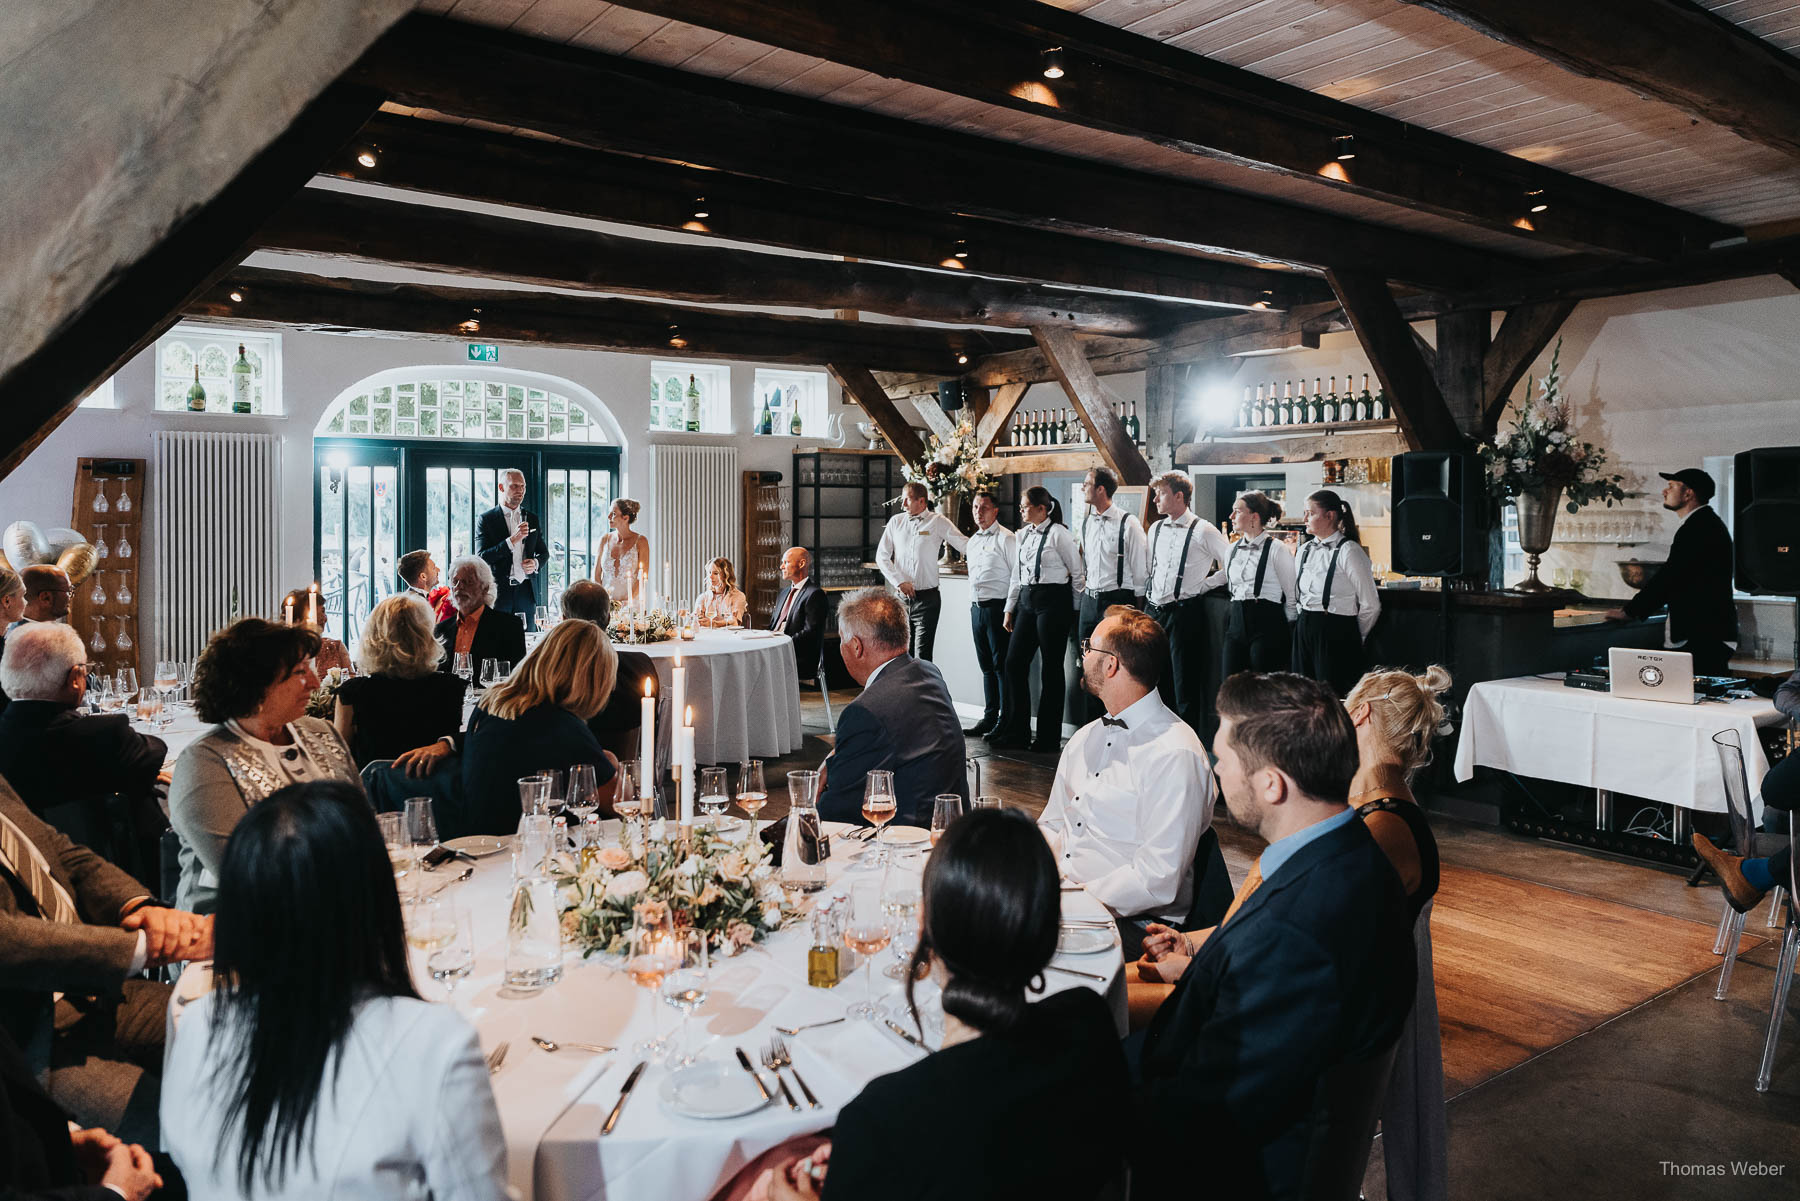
[1456,675,1786,814]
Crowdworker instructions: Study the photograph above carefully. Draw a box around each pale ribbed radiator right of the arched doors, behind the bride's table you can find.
[650,447,743,609]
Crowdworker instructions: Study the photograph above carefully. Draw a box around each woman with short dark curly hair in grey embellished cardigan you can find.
[169,618,362,913]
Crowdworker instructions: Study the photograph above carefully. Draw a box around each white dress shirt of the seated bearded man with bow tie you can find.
[1037,690,1215,922]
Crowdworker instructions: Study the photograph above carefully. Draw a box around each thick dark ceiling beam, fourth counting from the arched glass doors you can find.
[349,14,1532,288]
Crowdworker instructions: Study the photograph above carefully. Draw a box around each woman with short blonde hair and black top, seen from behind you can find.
[333,592,468,769]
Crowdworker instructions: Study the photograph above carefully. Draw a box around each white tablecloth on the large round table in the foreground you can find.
[435,823,1125,1201]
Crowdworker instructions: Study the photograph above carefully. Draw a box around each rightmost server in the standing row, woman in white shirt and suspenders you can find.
[1292,490,1381,697]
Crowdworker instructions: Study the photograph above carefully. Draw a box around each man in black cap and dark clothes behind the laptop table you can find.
[1606,466,1737,675]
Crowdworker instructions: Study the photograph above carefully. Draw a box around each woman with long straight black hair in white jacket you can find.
[162,783,506,1201]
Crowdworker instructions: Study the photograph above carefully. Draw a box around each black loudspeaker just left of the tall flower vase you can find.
[1393,450,1487,576]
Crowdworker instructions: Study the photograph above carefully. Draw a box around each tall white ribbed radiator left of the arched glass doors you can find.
[149,430,281,659]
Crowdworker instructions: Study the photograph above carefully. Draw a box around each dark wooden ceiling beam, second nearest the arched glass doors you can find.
[256,187,1192,337]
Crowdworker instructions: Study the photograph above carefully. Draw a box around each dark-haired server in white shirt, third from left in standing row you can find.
[988,484,1087,753]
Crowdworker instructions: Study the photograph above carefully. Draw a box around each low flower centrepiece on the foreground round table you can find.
[554,821,796,956]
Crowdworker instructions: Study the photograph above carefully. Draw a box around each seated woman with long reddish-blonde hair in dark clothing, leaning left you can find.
[460,621,619,837]
